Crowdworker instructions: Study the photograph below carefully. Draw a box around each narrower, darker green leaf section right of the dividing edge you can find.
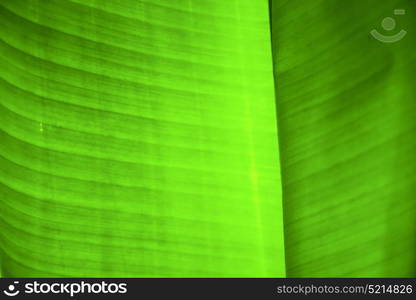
[272,0,416,277]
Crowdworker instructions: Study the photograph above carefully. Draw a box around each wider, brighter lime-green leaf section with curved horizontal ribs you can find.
[0,0,285,277]
